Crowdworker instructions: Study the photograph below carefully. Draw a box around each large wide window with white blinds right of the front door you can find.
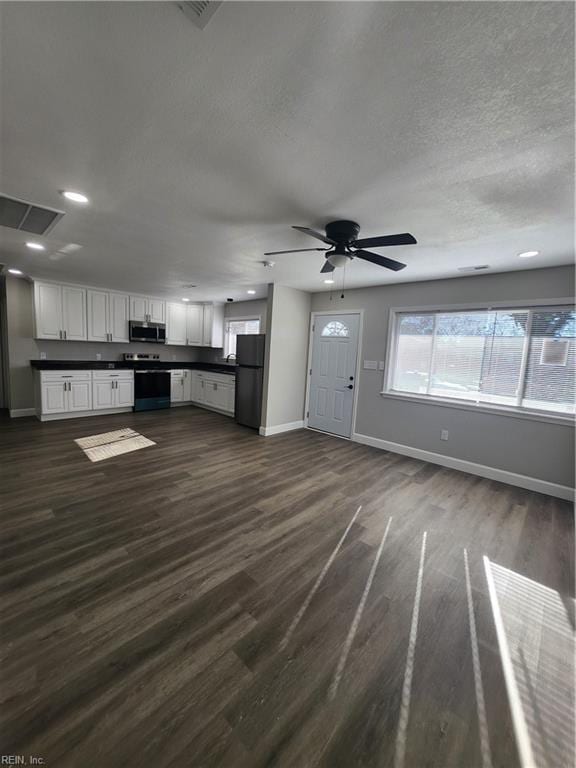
[386,306,576,414]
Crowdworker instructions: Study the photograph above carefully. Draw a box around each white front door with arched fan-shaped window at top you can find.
[308,314,360,437]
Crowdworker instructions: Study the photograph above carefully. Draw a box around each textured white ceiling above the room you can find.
[0,2,574,298]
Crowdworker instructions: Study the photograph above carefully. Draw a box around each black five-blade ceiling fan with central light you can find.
[264,221,416,273]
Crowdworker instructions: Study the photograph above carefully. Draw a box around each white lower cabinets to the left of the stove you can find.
[36,370,134,419]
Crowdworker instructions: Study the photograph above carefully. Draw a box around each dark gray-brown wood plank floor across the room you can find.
[0,408,573,768]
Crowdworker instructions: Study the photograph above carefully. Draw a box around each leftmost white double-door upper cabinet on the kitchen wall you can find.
[34,283,88,341]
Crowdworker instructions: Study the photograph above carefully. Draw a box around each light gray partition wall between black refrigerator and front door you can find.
[262,285,311,431]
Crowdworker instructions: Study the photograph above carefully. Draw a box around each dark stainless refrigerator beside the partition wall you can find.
[234,333,265,429]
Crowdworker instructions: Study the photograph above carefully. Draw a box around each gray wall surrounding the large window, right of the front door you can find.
[312,267,574,487]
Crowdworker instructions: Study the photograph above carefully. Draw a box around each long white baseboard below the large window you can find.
[352,432,575,501]
